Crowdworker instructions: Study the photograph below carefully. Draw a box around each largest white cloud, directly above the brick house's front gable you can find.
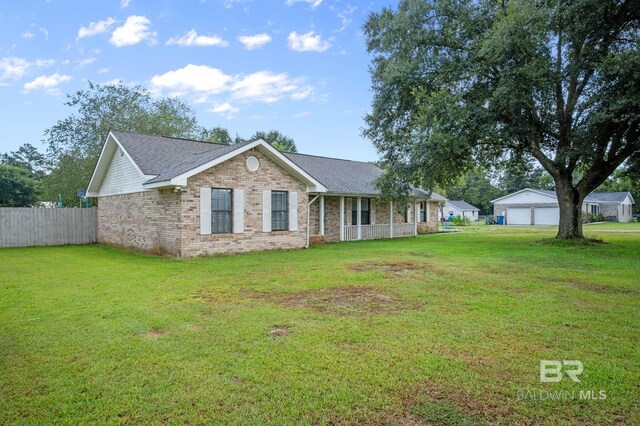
[150,64,314,116]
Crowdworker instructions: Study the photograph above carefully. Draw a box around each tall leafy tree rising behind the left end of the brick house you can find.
[44,82,202,205]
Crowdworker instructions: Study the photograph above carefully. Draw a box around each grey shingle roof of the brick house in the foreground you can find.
[112,131,445,201]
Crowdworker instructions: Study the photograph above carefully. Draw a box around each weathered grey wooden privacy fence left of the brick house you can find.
[0,207,98,247]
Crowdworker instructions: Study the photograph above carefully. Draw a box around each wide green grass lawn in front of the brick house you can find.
[0,223,640,425]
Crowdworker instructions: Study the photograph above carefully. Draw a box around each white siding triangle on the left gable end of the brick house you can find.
[98,147,147,197]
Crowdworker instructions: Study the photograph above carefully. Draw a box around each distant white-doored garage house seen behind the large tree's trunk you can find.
[491,188,635,225]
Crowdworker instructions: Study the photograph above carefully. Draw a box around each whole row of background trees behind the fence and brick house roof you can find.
[0,82,297,207]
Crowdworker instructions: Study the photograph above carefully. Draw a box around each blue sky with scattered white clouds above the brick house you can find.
[0,0,393,161]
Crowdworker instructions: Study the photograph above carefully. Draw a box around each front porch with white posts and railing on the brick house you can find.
[309,195,438,241]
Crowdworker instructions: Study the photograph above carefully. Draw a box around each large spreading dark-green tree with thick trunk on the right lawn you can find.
[363,0,640,238]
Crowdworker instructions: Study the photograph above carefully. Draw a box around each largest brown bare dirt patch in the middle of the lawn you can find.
[242,287,415,315]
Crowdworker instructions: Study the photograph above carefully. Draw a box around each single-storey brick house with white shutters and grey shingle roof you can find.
[87,131,444,256]
